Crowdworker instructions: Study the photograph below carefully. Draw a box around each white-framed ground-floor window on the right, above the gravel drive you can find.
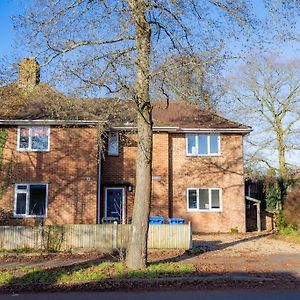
[187,188,221,211]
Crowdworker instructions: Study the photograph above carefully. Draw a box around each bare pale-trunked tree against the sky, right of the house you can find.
[228,56,300,178]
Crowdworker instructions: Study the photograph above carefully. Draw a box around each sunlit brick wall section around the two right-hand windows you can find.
[170,134,245,232]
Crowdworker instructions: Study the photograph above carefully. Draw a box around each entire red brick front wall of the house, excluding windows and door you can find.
[0,127,245,232]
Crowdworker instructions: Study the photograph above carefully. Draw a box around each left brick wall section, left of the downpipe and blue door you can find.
[0,127,98,225]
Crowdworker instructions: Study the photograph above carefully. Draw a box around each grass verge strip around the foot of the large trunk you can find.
[0,262,196,285]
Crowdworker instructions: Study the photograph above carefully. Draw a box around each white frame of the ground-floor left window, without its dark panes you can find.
[13,182,48,218]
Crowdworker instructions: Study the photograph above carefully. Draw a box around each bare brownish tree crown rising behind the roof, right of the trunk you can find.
[151,49,225,108]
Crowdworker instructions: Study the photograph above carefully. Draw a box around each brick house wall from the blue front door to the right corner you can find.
[101,132,245,232]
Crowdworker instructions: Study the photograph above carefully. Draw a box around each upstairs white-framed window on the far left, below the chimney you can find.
[18,126,50,151]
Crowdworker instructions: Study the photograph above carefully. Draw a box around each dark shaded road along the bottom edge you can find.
[0,290,300,300]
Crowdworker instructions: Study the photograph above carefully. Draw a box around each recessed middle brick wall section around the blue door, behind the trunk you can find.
[101,132,169,220]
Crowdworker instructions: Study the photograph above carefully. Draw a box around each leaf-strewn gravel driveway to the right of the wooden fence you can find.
[183,234,300,278]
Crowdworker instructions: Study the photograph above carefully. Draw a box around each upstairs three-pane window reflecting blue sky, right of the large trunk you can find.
[186,134,220,156]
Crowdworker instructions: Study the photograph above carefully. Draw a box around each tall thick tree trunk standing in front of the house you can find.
[126,0,152,269]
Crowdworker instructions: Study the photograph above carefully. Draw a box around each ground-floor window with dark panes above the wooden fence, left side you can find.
[14,183,48,217]
